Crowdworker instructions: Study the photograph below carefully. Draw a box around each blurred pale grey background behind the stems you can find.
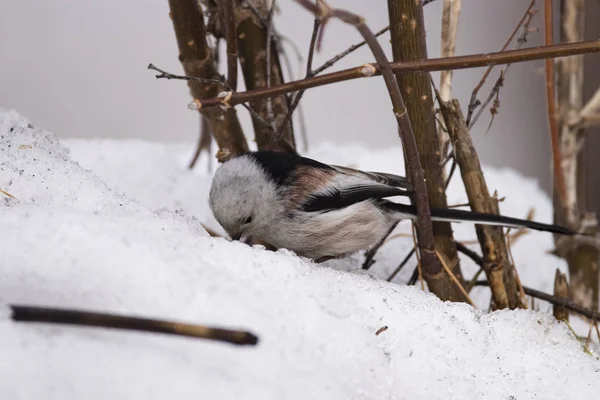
[0,0,600,205]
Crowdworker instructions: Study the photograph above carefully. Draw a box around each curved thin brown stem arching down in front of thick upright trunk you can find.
[296,0,442,276]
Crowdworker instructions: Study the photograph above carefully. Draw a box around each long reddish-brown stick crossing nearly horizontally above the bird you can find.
[193,40,600,108]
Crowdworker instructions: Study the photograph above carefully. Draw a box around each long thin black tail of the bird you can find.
[386,202,578,235]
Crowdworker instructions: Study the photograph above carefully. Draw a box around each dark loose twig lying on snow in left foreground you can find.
[10,305,258,345]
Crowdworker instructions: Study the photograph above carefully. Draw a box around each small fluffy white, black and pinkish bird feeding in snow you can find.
[209,151,576,262]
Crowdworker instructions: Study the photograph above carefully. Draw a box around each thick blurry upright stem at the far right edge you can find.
[554,0,600,308]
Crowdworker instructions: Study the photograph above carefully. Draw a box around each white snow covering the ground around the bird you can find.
[0,109,600,400]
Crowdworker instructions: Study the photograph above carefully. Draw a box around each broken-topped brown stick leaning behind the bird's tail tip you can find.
[436,96,520,309]
